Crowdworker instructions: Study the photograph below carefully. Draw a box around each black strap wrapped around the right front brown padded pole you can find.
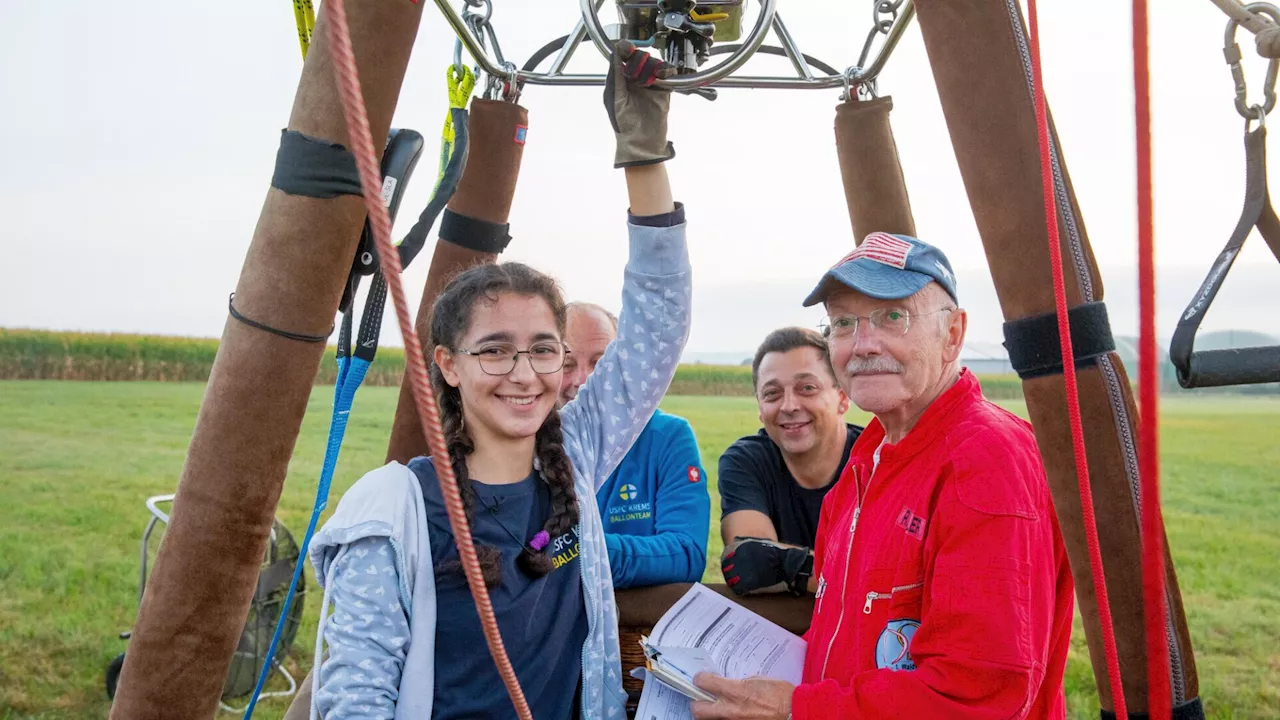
[1005,302,1116,380]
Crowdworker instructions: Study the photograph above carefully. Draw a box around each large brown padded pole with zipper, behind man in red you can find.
[916,0,1203,717]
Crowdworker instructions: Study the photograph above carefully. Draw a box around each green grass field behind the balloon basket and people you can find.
[0,382,1280,720]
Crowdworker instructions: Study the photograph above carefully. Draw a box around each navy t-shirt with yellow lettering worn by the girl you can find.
[410,457,586,720]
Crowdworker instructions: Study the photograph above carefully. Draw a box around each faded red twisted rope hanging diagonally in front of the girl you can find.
[324,0,532,720]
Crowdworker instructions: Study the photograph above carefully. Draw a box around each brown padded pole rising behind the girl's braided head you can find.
[387,97,529,462]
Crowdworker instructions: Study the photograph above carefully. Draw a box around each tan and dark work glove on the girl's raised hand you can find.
[604,40,676,168]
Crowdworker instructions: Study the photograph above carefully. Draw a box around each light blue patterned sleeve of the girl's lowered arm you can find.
[315,537,410,720]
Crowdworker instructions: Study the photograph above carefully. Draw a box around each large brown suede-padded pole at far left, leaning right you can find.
[111,0,422,720]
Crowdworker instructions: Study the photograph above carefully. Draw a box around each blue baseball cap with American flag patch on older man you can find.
[804,232,960,307]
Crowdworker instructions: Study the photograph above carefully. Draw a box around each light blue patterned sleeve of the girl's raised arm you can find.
[561,217,691,489]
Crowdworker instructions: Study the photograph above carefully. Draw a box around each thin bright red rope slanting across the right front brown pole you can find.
[1027,0,1129,719]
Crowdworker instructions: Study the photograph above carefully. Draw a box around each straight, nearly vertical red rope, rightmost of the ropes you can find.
[1133,0,1172,717]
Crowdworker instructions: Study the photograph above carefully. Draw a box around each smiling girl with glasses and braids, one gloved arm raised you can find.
[310,44,690,720]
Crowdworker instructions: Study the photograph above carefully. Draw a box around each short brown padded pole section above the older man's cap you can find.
[836,96,915,242]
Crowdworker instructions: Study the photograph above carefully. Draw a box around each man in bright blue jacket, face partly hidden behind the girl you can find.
[559,302,710,588]
